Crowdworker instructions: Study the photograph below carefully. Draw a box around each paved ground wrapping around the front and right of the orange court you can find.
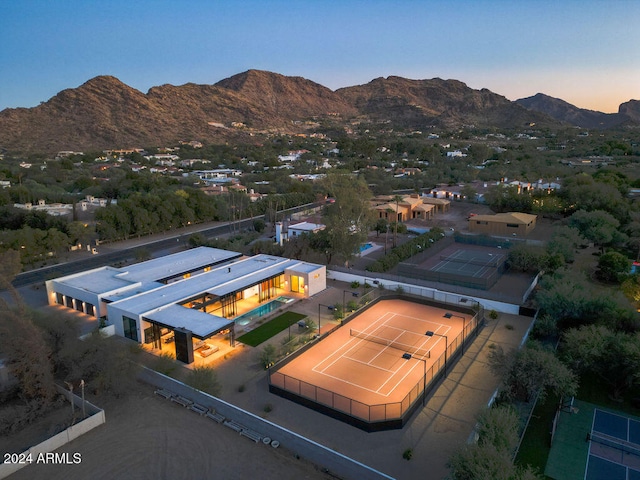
[216,283,532,479]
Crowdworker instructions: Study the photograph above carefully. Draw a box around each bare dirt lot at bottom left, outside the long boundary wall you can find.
[9,384,332,480]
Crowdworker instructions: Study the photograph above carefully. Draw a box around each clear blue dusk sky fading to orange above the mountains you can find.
[0,0,640,112]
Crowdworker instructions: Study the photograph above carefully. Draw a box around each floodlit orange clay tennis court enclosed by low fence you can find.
[270,298,477,428]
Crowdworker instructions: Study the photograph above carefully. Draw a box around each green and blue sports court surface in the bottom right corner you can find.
[545,401,640,480]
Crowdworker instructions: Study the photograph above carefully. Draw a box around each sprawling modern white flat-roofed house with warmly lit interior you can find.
[46,247,326,363]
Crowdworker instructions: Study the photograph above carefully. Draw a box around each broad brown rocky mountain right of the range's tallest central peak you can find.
[336,76,557,128]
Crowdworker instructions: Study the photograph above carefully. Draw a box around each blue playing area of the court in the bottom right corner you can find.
[585,409,640,480]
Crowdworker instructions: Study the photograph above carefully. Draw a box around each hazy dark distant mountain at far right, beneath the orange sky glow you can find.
[516,93,640,129]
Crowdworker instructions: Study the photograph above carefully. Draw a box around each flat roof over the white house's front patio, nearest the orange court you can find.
[145,305,233,338]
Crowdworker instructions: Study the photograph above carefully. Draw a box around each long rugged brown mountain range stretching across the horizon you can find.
[0,70,640,153]
